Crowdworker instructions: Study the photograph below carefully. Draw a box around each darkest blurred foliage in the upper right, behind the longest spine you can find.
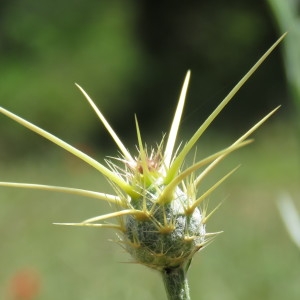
[127,0,289,137]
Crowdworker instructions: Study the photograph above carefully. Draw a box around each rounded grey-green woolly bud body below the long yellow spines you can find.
[122,171,205,270]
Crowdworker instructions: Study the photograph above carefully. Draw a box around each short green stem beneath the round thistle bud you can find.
[161,267,191,300]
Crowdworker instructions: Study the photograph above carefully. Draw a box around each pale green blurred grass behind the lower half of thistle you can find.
[0,119,300,300]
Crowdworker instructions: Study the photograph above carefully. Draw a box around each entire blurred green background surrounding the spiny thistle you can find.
[0,0,300,300]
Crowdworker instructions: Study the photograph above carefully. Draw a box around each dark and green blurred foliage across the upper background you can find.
[0,0,289,157]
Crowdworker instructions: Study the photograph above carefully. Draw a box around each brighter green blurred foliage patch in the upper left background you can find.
[0,0,145,158]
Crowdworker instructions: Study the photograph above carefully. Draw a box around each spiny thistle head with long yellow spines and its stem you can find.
[0,35,284,300]
